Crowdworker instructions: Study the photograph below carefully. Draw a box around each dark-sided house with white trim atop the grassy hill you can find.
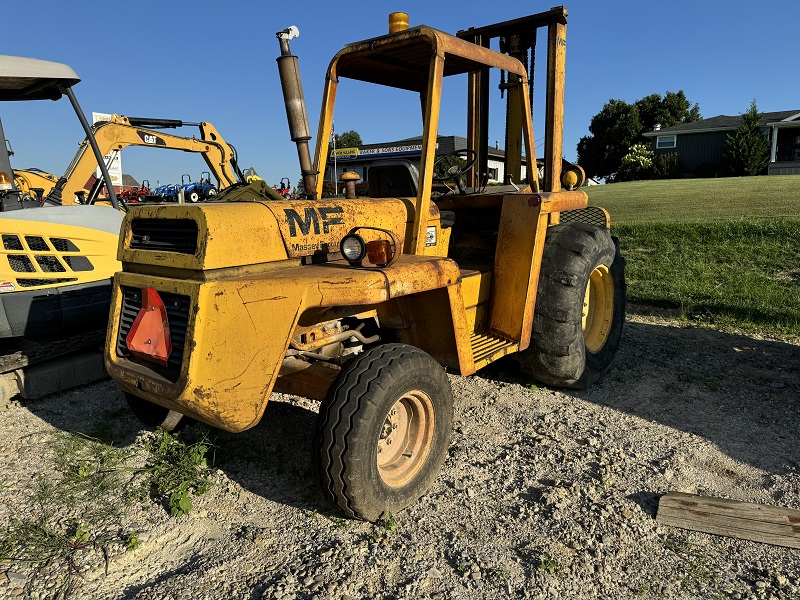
[644,110,800,177]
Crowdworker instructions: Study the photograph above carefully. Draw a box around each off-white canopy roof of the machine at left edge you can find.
[0,55,81,101]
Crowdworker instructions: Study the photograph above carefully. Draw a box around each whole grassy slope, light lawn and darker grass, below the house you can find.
[587,176,800,336]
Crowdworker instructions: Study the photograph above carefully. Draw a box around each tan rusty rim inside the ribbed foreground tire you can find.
[378,390,434,487]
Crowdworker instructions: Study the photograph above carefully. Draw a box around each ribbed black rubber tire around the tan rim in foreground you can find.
[312,344,453,521]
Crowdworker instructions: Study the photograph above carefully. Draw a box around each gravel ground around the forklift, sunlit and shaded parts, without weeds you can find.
[0,317,800,600]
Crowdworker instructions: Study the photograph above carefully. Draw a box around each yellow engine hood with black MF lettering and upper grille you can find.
[118,198,413,270]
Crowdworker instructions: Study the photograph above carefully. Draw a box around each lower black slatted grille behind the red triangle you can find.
[117,286,191,383]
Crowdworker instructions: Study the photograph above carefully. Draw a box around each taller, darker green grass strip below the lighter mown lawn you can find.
[614,219,800,335]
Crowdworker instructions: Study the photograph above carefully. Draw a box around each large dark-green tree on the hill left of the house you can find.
[578,90,701,181]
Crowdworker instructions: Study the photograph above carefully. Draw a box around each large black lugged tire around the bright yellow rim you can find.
[517,223,626,389]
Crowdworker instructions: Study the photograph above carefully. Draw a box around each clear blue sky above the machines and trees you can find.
[0,0,800,185]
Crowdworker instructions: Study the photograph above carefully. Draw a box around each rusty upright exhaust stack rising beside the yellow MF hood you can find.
[275,25,317,200]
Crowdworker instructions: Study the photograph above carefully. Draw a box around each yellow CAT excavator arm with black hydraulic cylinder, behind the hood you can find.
[48,115,238,204]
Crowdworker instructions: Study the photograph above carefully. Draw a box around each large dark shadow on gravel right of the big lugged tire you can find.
[506,322,800,478]
